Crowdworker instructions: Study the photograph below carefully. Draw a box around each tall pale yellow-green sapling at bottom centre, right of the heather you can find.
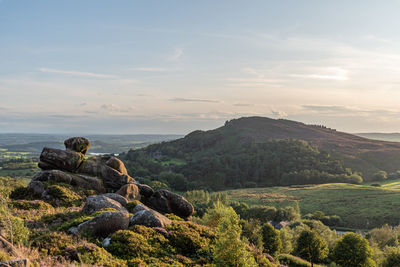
[204,202,256,266]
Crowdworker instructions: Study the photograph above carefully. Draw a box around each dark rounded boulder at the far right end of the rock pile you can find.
[148,189,194,219]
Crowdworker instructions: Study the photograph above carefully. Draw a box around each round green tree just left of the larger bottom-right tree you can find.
[295,230,329,267]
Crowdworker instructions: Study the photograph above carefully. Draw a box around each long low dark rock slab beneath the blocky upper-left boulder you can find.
[31,170,106,193]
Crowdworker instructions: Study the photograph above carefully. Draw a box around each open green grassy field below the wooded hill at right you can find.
[227,183,400,229]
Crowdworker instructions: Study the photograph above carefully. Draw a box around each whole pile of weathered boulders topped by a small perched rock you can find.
[28,137,194,239]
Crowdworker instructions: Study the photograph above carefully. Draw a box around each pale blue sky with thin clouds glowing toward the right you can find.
[0,0,400,134]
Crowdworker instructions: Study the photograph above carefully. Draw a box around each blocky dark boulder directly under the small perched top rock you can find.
[39,147,84,172]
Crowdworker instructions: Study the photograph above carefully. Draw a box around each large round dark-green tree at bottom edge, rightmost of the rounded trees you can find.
[332,233,375,267]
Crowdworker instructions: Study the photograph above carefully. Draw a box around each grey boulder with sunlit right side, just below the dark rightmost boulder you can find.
[129,204,171,227]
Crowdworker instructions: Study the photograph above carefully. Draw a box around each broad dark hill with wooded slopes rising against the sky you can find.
[121,117,400,191]
